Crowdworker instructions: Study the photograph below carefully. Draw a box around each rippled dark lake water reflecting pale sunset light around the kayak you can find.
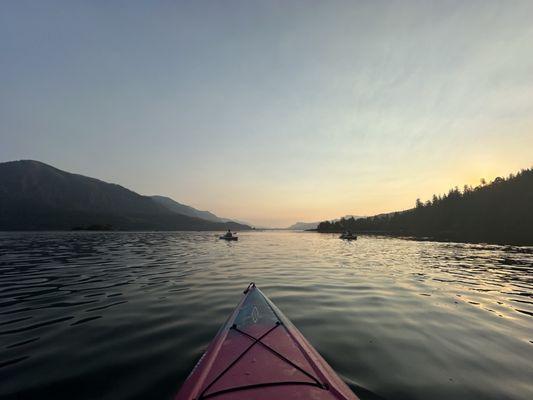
[0,232,533,399]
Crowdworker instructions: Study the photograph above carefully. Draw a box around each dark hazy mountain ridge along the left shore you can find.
[0,160,251,230]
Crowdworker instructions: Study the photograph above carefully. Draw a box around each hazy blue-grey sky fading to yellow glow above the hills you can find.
[0,0,533,227]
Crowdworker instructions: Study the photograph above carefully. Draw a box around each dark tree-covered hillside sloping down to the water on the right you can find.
[317,169,533,245]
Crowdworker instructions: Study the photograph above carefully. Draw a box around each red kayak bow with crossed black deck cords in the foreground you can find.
[176,283,358,400]
